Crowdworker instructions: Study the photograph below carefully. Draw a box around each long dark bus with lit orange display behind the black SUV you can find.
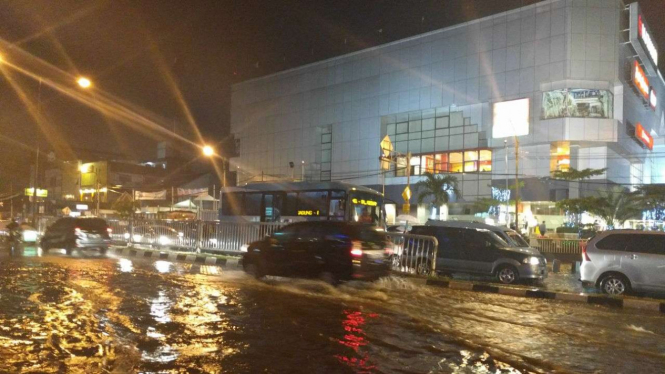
[219,182,385,227]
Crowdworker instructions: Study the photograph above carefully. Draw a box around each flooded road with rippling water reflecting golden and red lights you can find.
[0,247,665,373]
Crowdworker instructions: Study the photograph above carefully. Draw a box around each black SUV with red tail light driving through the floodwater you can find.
[242,222,391,284]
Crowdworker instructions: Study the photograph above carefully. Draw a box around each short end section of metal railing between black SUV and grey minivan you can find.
[388,233,439,275]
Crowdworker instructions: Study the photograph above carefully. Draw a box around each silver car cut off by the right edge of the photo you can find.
[580,230,665,295]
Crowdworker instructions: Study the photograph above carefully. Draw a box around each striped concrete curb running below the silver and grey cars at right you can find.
[409,277,665,313]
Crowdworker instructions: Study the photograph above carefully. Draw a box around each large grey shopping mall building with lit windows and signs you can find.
[231,0,665,223]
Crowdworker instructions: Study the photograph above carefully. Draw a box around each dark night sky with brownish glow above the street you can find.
[0,0,665,184]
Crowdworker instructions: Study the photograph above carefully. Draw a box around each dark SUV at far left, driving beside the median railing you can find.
[40,217,111,255]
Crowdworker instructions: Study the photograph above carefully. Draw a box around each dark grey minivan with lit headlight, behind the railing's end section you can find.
[411,225,547,284]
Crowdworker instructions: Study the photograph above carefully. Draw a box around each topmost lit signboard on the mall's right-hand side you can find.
[629,3,658,76]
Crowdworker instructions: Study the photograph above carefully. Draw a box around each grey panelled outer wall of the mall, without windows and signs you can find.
[231,0,665,200]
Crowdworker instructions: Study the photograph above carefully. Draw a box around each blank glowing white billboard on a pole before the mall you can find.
[492,98,529,139]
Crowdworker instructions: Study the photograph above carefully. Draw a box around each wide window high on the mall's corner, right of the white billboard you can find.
[541,88,614,119]
